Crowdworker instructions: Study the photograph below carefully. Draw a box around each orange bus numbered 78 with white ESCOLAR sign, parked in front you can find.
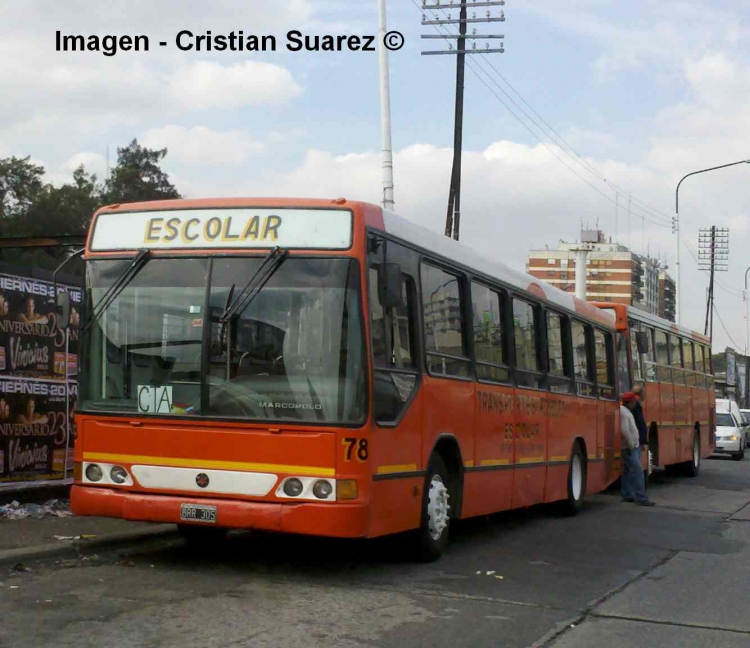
[71,199,620,560]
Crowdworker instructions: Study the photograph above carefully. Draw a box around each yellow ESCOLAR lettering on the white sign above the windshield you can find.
[143,215,282,245]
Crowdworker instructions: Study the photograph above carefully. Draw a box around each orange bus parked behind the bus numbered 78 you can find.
[594,302,716,477]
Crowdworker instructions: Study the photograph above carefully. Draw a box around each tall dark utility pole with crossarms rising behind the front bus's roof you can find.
[422,0,505,241]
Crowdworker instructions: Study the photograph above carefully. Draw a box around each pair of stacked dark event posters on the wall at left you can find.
[0,273,82,484]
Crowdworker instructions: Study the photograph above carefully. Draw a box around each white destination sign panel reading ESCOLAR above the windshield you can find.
[91,207,352,251]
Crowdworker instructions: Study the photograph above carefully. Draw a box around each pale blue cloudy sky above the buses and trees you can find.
[0,0,750,351]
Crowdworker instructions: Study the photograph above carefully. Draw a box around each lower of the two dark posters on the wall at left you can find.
[0,378,77,483]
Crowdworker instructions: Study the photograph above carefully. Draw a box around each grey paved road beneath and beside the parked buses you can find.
[0,459,750,648]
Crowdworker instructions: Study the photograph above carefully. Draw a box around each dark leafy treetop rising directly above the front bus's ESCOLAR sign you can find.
[101,139,181,205]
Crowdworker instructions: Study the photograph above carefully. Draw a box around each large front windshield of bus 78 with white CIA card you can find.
[81,257,366,424]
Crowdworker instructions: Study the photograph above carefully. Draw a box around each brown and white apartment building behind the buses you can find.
[526,230,675,321]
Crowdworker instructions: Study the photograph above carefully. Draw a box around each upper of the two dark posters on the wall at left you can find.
[0,274,82,380]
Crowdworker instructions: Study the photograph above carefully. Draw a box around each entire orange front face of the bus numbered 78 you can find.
[71,201,376,537]
